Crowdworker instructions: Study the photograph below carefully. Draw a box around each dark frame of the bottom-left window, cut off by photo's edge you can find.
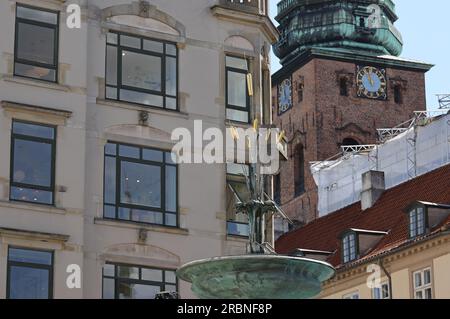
[6,246,55,299]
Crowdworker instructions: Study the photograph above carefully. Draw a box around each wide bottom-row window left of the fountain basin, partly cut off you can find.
[103,264,178,299]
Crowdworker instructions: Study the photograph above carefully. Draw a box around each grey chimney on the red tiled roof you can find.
[361,171,386,211]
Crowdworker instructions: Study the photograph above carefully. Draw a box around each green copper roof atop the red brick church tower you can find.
[274,0,403,65]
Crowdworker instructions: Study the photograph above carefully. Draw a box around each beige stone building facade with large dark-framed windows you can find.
[0,0,278,299]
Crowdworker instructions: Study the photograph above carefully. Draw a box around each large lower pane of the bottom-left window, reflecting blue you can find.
[9,266,50,299]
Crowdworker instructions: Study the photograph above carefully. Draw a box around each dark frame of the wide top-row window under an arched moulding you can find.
[105,30,180,112]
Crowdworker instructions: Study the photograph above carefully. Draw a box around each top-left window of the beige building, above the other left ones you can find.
[14,5,59,82]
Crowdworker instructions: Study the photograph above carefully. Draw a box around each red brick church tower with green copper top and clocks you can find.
[272,0,432,225]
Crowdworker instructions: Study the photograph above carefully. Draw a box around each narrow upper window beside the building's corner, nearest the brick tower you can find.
[226,56,250,123]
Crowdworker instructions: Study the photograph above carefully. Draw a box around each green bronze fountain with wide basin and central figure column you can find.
[177,124,335,299]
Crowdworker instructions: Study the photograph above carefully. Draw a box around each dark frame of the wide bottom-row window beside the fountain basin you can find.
[102,262,180,300]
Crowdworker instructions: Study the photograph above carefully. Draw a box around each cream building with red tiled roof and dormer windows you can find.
[276,164,450,299]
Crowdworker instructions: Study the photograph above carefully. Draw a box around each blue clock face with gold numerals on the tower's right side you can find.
[356,66,387,100]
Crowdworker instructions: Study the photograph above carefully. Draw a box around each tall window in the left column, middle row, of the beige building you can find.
[10,121,56,205]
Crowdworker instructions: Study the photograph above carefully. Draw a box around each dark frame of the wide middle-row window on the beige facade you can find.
[103,141,180,228]
